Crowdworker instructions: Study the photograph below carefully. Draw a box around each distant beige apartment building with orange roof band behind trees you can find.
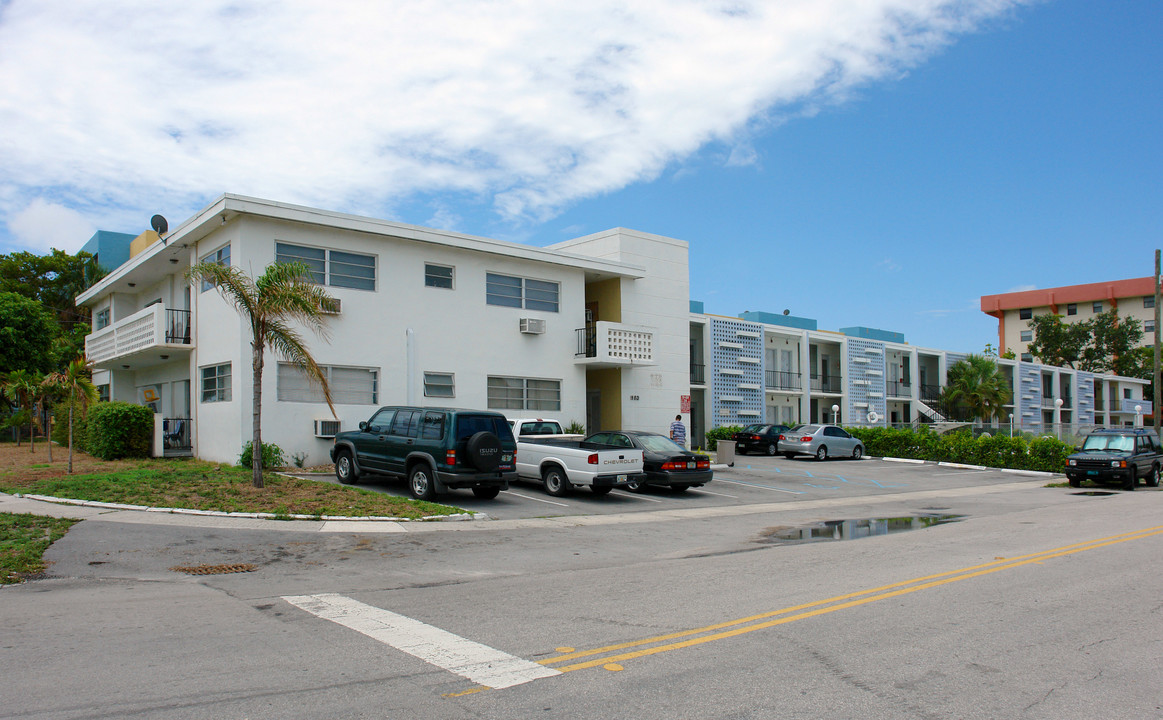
[982,277,1155,362]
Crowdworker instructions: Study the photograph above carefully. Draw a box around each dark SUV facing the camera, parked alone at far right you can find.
[1066,428,1163,490]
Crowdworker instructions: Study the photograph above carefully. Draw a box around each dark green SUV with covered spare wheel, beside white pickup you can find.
[331,406,516,500]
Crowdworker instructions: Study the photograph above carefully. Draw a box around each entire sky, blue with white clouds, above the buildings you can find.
[0,0,1163,351]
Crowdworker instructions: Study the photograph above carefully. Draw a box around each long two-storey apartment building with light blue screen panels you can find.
[690,311,1151,443]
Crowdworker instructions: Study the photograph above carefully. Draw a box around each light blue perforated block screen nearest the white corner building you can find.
[711,318,764,427]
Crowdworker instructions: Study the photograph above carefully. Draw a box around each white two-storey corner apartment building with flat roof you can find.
[78,194,690,464]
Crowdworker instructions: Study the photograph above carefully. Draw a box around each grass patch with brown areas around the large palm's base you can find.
[0,448,464,519]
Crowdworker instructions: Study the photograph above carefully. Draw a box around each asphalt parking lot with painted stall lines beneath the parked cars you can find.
[316,455,1063,520]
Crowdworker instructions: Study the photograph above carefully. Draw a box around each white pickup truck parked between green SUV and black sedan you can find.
[509,418,645,498]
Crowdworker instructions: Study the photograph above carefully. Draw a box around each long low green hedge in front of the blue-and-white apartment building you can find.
[846,427,1073,472]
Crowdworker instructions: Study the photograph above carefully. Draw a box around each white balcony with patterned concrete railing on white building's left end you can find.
[85,304,194,370]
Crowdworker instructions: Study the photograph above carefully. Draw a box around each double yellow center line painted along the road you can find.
[538,526,1163,672]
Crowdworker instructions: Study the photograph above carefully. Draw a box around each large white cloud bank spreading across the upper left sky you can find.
[0,0,1025,241]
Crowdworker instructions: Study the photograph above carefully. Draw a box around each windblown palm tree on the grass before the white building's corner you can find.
[186,262,335,487]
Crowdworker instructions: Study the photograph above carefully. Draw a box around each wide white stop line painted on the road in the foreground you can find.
[283,593,561,689]
